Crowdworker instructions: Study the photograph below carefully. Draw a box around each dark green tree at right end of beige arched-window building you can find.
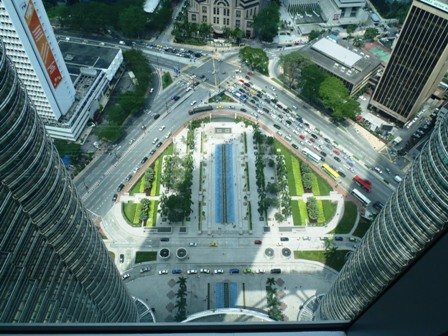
[253,1,280,42]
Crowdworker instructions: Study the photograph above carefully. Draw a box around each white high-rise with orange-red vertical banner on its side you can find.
[0,0,83,140]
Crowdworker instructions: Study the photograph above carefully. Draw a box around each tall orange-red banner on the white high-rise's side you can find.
[25,0,62,88]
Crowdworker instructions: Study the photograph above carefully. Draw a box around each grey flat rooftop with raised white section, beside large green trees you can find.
[302,37,381,84]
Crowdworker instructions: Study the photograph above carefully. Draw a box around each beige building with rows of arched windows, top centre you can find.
[188,0,263,37]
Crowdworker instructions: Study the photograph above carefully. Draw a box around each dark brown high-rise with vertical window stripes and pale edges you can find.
[370,0,448,123]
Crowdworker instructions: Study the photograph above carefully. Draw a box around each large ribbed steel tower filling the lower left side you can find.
[0,43,138,323]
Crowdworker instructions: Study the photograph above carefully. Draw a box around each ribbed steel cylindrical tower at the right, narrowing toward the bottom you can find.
[315,106,448,320]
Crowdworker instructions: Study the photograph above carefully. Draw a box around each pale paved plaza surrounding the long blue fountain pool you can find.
[102,120,354,322]
